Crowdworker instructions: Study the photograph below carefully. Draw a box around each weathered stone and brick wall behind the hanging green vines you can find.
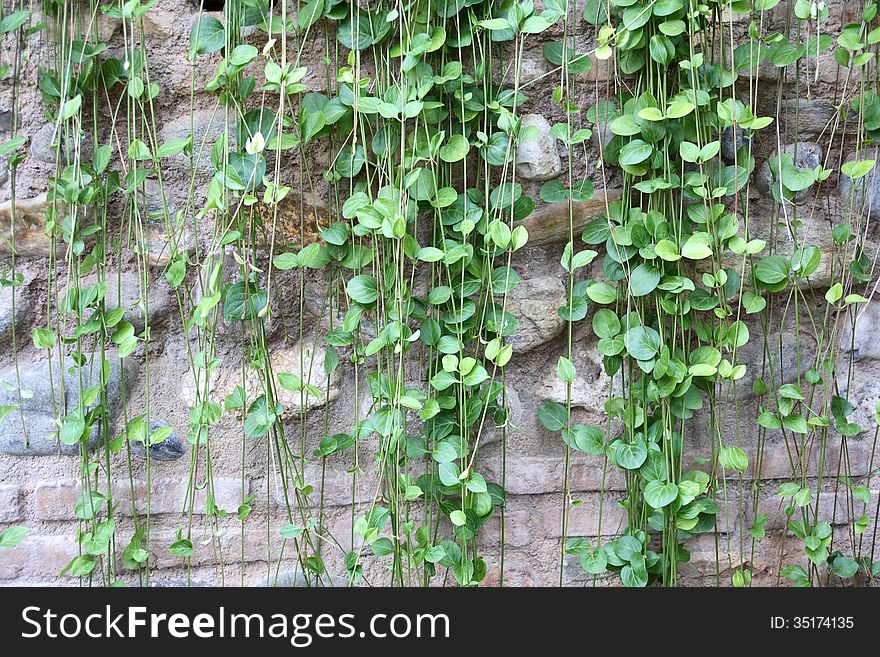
[0,0,880,586]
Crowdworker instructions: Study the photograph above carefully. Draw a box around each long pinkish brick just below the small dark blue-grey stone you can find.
[34,477,249,520]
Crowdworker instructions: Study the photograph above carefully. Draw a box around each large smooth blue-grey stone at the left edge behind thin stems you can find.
[0,352,136,456]
